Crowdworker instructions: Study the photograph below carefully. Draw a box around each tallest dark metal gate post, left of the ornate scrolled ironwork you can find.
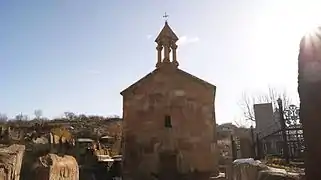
[277,98,290,164]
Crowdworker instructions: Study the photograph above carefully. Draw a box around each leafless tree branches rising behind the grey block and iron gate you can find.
[240,87,291,121]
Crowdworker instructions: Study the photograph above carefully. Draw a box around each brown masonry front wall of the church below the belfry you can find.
[123,68,218,179]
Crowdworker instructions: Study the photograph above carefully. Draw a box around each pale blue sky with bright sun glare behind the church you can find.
[0,0,320,123]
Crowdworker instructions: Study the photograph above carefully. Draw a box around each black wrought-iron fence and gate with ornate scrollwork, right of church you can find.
[252,102,305,163]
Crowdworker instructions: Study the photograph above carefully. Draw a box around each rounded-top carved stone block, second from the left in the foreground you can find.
[34,154,79,180]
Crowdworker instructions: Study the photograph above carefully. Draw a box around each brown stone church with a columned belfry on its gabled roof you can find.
[121,21,218,179]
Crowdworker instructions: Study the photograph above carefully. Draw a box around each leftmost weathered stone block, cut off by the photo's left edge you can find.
[0,144,25,180]
